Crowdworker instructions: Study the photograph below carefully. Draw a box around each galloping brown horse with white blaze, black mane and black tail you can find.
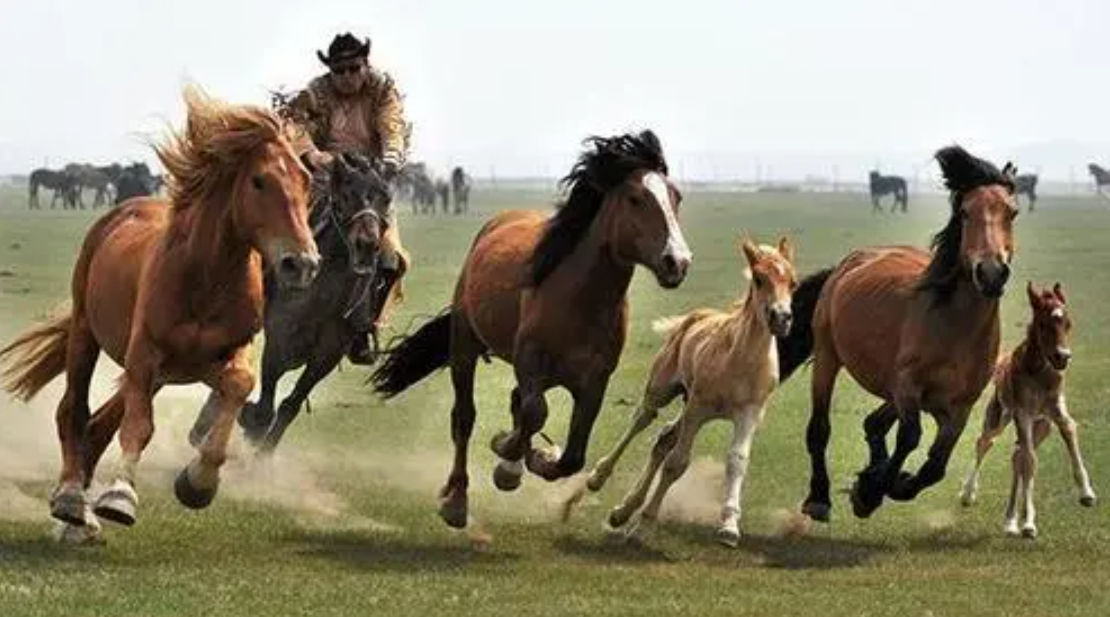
[373,131,692,527]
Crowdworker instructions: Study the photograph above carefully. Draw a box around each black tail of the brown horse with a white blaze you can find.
[370,311,451,398]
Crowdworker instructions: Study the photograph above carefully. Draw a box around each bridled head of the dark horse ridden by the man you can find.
[330,154,392,274]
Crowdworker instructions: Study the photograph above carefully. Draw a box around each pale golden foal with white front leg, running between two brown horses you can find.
[587,237,797,546]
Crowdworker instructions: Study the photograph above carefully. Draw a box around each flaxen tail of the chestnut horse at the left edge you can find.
[0,311,73,401]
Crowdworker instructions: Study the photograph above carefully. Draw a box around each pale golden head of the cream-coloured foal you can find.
[740,237,798,337]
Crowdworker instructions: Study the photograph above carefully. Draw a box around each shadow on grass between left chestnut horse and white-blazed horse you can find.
[283,532,521,574]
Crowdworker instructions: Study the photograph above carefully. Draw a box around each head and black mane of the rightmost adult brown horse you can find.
[926,145,1018,299]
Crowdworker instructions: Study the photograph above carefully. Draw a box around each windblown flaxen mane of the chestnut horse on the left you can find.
[154,87,292,211]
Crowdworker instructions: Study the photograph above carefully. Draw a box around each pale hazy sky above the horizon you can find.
[0,0,1110,179]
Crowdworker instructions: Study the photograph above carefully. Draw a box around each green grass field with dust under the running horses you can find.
[0,184,1110,617]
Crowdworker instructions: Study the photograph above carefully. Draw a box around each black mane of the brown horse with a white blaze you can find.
[532,130,667,286]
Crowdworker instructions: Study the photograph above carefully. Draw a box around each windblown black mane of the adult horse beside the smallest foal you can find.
[918,145,1015,303]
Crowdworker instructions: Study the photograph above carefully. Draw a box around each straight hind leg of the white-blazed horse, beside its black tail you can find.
[440,328,479,529]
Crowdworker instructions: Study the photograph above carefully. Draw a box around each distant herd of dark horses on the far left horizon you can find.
[28,163,162,210]
